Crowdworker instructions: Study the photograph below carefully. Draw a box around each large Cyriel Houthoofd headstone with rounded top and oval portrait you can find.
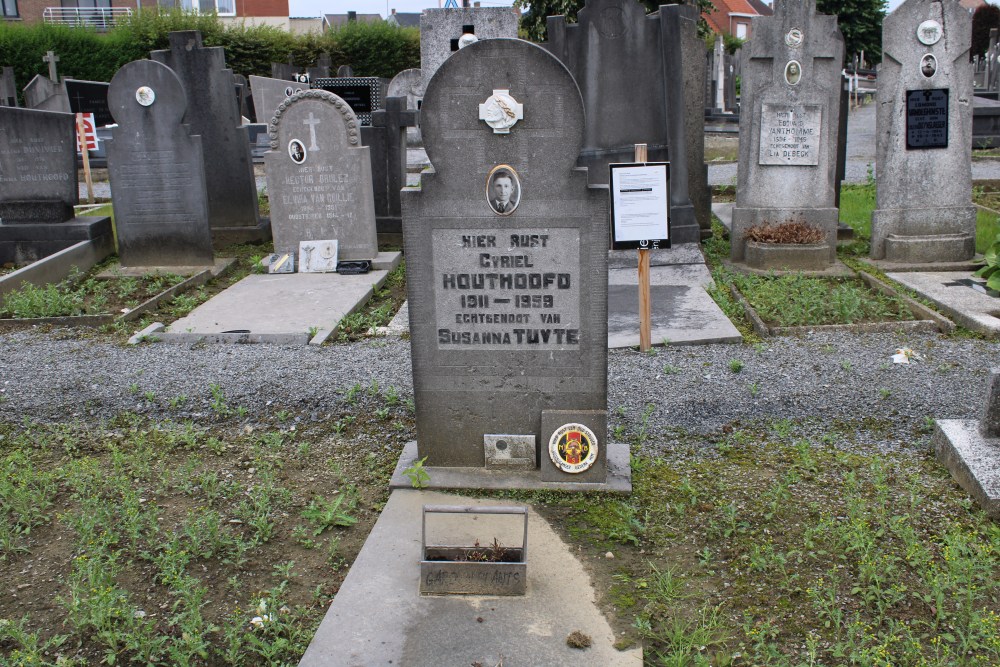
[401,39,608,483]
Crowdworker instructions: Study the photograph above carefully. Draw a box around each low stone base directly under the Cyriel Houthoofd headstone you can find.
[389,440,632,494]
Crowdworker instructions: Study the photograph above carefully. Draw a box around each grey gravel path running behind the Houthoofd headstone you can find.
[0,332,1000,448]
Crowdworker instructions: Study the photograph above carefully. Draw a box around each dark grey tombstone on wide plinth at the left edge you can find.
[0,107,111,264]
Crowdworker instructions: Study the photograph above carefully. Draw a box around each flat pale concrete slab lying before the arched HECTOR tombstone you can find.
[160,253,400,344]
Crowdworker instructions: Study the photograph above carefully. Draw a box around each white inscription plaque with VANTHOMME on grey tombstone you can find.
[758,103,823,166]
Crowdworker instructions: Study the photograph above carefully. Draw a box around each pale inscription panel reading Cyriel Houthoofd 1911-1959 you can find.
[433,228,581,350]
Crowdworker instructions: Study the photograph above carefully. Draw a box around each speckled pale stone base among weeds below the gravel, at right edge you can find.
[934,419,1000,519]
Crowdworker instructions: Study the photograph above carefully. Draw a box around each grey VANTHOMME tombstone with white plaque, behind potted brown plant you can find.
[730,0,844,270]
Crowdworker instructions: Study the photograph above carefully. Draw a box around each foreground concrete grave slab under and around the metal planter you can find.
[299,489,642,667]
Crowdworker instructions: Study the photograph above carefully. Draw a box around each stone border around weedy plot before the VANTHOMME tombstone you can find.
[729,271,955,338]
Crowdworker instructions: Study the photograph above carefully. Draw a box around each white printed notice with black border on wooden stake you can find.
[610,162,670,250]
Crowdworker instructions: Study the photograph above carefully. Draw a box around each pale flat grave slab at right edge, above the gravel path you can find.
[886,271,1000,337]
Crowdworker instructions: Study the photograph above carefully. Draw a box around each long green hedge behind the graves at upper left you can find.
[0,10,420,103]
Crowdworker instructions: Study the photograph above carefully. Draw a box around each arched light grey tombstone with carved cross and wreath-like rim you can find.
[264,90,378,260]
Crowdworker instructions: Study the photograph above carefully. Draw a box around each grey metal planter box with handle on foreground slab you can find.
[420,505,528,595]
